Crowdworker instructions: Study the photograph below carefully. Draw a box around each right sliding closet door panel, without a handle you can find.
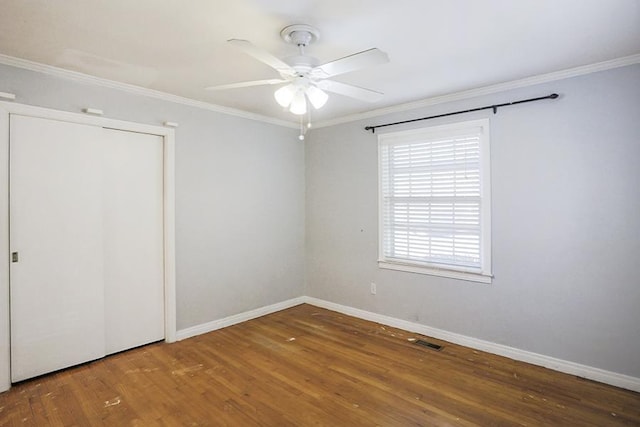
[102,129,164,354]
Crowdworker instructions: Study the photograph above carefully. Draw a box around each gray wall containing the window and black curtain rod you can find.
[306,65,640,377]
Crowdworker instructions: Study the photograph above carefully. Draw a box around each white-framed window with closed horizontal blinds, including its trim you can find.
[378,120,491,283]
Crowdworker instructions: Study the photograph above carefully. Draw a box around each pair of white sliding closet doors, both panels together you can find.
[10,115,165,382]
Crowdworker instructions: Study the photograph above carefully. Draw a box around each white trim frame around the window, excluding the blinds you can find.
[378,119,493,283]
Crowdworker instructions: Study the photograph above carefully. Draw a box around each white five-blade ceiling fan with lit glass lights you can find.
[206,24,389,115]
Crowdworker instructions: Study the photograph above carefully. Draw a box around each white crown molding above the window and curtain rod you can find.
[313,54,640,129]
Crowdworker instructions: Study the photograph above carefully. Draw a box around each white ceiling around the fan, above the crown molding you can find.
[0,0,640,122]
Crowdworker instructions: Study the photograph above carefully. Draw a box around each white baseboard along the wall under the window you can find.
[302,297,640,392]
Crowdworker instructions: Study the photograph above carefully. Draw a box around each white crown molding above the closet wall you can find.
[0,54,298,129]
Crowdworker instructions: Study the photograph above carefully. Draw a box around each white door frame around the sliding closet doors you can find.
[0,101,176,392]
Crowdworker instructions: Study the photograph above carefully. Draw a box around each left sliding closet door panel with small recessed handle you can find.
[10,115,105,382]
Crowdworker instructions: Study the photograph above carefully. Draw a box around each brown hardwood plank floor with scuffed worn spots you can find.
[0,305,640,426]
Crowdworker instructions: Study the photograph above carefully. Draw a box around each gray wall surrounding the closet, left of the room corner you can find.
[0,65,305,330]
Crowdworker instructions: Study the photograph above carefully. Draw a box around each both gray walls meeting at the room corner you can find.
[0,60,640,377]
